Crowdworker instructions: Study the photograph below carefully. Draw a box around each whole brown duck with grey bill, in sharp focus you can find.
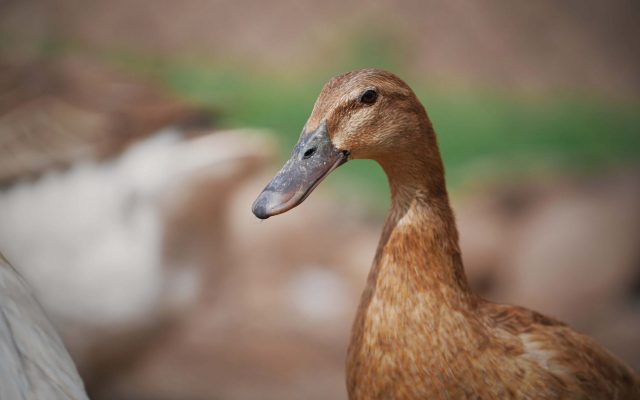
[252,69,640,400]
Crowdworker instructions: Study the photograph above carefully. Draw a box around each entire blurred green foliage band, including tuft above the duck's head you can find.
[4,31,640,211]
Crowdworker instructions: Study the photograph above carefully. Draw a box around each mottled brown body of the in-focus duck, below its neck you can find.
[347,181,638,399]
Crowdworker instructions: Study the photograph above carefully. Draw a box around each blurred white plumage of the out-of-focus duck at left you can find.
[0,128,272,329]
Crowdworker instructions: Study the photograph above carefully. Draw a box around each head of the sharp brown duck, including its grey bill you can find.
[252,69,428,219]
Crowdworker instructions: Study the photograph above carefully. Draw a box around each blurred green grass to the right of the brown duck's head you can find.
[424,95,640,182]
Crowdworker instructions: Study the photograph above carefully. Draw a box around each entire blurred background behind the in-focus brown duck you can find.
[0,0,640,400]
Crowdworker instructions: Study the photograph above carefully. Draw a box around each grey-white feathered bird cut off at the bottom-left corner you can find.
[0,253,89,400]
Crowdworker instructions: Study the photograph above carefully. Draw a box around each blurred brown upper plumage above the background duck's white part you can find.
[0,58,215,186]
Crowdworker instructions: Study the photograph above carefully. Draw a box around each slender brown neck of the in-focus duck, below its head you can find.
[369,125,475,308]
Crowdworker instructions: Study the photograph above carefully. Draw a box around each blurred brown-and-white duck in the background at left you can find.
[0,55,272,398]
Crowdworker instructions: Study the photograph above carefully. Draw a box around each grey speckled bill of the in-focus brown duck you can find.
[252,122,349,219]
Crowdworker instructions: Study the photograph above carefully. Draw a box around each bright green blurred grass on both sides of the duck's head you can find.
[119,63,640,208]
